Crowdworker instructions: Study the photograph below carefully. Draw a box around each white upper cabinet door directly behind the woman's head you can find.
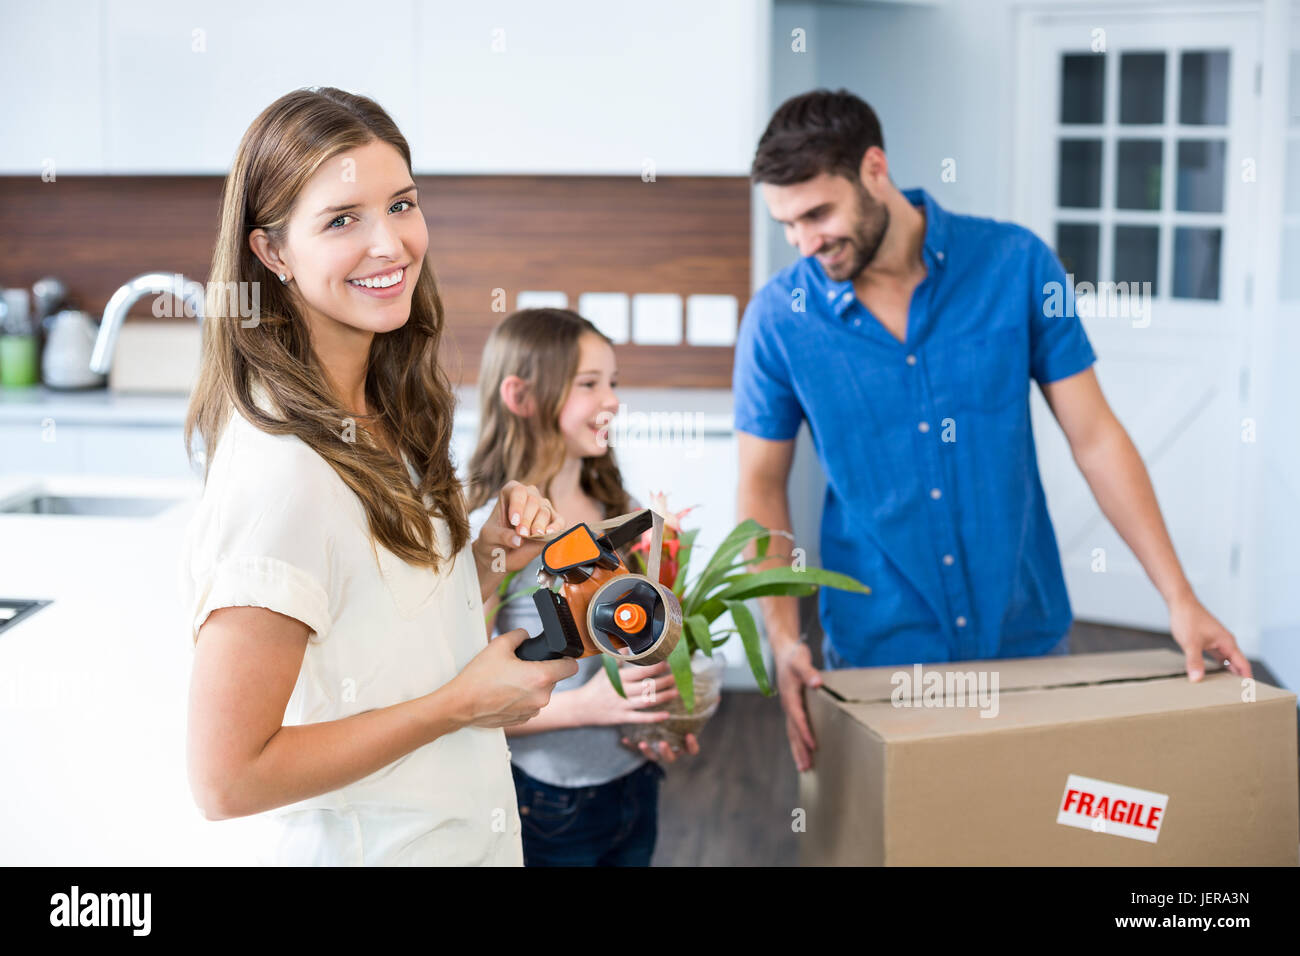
[102,0,417,174]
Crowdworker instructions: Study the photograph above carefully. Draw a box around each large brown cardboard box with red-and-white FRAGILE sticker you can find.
[800,650,1300,866]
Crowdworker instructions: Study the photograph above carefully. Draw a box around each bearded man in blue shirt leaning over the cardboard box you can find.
[733,90,1251,770]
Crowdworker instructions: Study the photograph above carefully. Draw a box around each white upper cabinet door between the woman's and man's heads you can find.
[415,0,770,176]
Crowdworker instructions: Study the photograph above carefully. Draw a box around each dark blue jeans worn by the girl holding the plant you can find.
[510,761,664,866]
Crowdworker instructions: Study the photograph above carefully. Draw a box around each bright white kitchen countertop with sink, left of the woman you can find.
[0,476,260,866]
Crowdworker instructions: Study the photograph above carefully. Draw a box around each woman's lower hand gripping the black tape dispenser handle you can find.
[446,627,585,727]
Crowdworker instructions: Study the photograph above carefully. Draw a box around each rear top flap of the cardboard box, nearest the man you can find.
[822,649,1222,702]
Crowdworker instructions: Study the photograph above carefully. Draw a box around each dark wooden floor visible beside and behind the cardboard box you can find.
[654,622,1300,866]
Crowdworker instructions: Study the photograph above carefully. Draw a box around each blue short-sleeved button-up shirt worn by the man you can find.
[733,190,1096,666]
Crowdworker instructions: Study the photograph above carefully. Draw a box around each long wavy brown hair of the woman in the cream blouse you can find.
[185,87,469,571]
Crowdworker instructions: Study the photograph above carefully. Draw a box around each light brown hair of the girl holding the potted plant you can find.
[469,308,628,516]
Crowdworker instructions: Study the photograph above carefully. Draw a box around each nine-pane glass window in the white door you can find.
[1053,41,1231,300]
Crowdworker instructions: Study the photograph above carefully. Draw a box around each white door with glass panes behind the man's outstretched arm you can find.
[1017,12,1260,630]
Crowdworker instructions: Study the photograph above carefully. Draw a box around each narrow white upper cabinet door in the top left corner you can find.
[0,0,104,174]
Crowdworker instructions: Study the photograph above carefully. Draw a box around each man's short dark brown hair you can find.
[750,90,885,186]
